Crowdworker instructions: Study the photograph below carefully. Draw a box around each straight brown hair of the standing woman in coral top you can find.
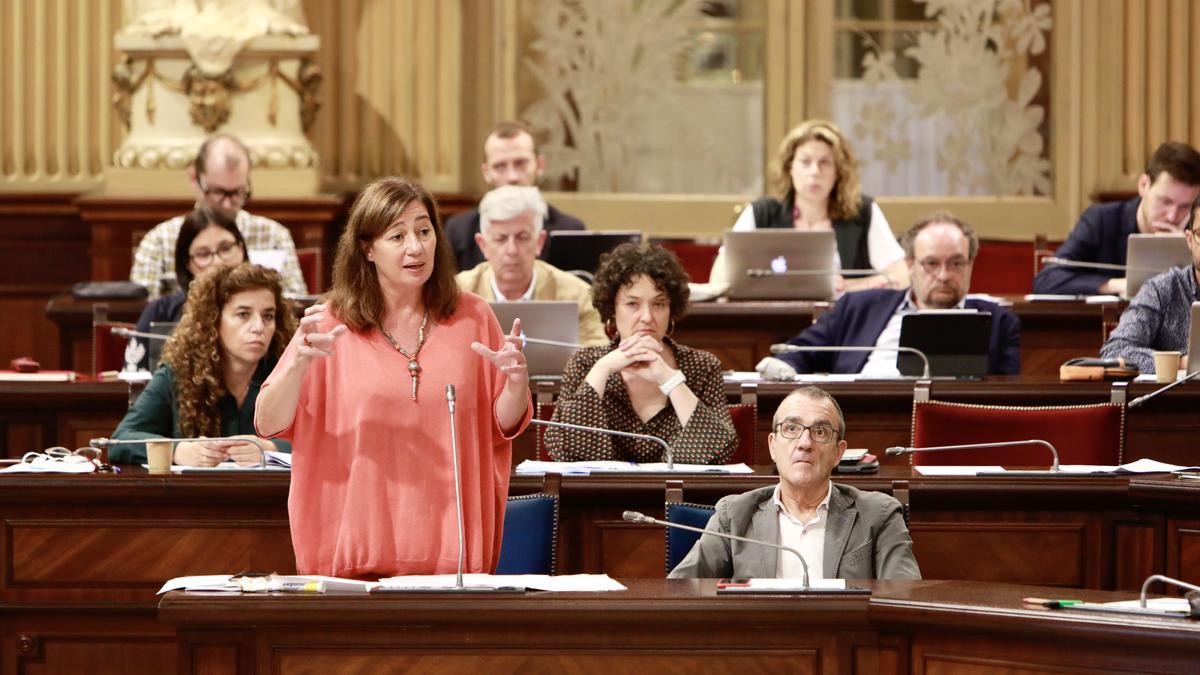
[326,177,458,333]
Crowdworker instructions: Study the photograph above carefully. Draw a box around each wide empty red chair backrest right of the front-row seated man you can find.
[908,400,1124,466]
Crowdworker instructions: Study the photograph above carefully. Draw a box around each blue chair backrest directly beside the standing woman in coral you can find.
[496,473,562,574]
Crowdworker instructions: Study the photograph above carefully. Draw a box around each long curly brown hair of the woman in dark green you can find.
[162,263,296,437]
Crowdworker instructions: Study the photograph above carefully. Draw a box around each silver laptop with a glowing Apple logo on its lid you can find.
[725,229,838,300]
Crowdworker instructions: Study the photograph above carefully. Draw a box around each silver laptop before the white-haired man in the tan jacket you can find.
[492,300,580,377]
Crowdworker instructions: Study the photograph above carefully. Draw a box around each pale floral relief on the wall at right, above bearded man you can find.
[851,0,1051,195]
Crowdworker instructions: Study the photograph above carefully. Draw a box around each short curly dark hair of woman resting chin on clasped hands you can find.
[592,243,691,322]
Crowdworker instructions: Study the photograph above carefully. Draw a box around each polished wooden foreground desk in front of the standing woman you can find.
[158,579,1200,675]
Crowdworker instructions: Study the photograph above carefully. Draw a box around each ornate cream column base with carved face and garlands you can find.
[104,0,322,197]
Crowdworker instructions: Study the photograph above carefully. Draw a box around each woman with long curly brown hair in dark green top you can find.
[109,263,296,466]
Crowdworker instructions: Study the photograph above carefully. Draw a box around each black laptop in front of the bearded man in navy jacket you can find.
[896,310,991,377]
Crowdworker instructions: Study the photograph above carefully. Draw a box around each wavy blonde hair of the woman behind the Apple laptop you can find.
[770,119,863,220]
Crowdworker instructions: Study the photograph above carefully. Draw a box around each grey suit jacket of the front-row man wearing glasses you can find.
[668,484,920,579]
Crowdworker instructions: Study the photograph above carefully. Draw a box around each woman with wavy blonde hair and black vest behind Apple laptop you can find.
[713,119,908,291]
